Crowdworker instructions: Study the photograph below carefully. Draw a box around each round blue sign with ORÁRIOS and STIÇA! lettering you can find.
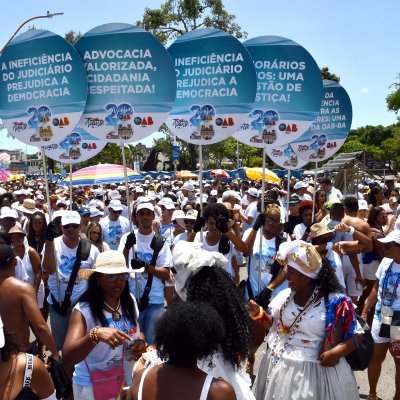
[234,36,322,147]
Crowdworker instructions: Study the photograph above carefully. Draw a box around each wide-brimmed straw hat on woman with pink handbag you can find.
[79,250,144,279]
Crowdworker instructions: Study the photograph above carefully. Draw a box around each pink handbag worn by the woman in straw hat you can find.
[85,355,125,400]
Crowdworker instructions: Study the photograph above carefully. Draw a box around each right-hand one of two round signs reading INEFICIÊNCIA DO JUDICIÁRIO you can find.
[166,28,256,144]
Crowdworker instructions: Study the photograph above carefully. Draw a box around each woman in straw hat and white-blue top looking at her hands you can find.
[63,250,146,400]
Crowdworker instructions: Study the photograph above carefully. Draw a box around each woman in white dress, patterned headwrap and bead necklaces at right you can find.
[253,240,363,400]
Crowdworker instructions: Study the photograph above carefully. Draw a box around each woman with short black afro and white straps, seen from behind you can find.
[127,302,236,400]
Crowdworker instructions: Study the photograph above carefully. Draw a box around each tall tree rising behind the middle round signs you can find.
[136,0,247,170]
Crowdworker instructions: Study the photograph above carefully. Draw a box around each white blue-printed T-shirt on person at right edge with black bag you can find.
[375,257,400,320]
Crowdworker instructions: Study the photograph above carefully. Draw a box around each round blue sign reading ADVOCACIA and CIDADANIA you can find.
[75,24,176,143]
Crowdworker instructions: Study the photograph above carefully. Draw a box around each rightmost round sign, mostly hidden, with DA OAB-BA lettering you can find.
[293,80,353,162]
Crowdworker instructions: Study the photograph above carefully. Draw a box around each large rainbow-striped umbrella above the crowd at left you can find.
[62,164,144,186]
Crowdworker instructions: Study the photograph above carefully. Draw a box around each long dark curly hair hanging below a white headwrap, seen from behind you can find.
[187,266,254,367]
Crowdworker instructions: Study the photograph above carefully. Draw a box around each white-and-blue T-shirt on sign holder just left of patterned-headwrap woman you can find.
[242,229,282,296]
